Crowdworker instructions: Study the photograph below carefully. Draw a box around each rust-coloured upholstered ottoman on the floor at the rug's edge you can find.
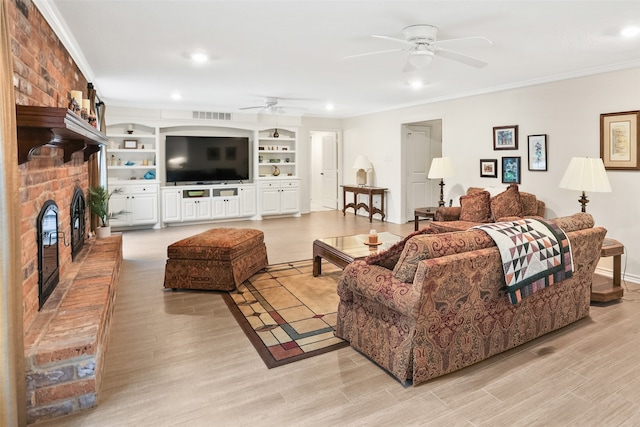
[164,228,268,291]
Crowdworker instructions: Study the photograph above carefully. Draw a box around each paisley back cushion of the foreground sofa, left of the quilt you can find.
[393,230,495,283]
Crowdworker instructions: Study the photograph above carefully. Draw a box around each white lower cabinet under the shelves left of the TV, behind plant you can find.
[109,184,158,228]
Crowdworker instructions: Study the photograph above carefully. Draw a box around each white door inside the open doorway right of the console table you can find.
[405,127,431,221]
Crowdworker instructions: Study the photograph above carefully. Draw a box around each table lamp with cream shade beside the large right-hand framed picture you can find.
[559,157,611,212]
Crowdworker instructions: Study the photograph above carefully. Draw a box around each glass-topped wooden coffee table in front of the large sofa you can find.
[313,231,403,277]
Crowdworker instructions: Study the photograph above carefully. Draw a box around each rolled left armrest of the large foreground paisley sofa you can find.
[338,261,420,319]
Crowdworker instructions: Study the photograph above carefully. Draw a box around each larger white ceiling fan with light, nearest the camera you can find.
[346,24,492,72]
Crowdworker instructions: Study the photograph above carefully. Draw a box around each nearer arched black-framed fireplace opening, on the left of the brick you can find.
[37,200,60,310]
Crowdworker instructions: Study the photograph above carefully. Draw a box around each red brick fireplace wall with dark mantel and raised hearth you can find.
[5,0,122,423]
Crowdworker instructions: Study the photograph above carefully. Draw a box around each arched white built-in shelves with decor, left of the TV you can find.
[106,123,158,185]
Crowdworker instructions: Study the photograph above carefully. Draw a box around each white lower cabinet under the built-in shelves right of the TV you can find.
[260,179,300,215]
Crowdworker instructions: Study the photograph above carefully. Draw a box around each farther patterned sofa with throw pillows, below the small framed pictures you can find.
[434,184,546,232]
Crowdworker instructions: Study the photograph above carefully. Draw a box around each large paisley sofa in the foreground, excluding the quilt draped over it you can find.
[336,213,606,385]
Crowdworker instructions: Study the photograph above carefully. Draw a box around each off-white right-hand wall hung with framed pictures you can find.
[343,68,640,283]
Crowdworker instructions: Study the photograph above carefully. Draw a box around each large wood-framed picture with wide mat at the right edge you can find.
[600,111,640,170]
